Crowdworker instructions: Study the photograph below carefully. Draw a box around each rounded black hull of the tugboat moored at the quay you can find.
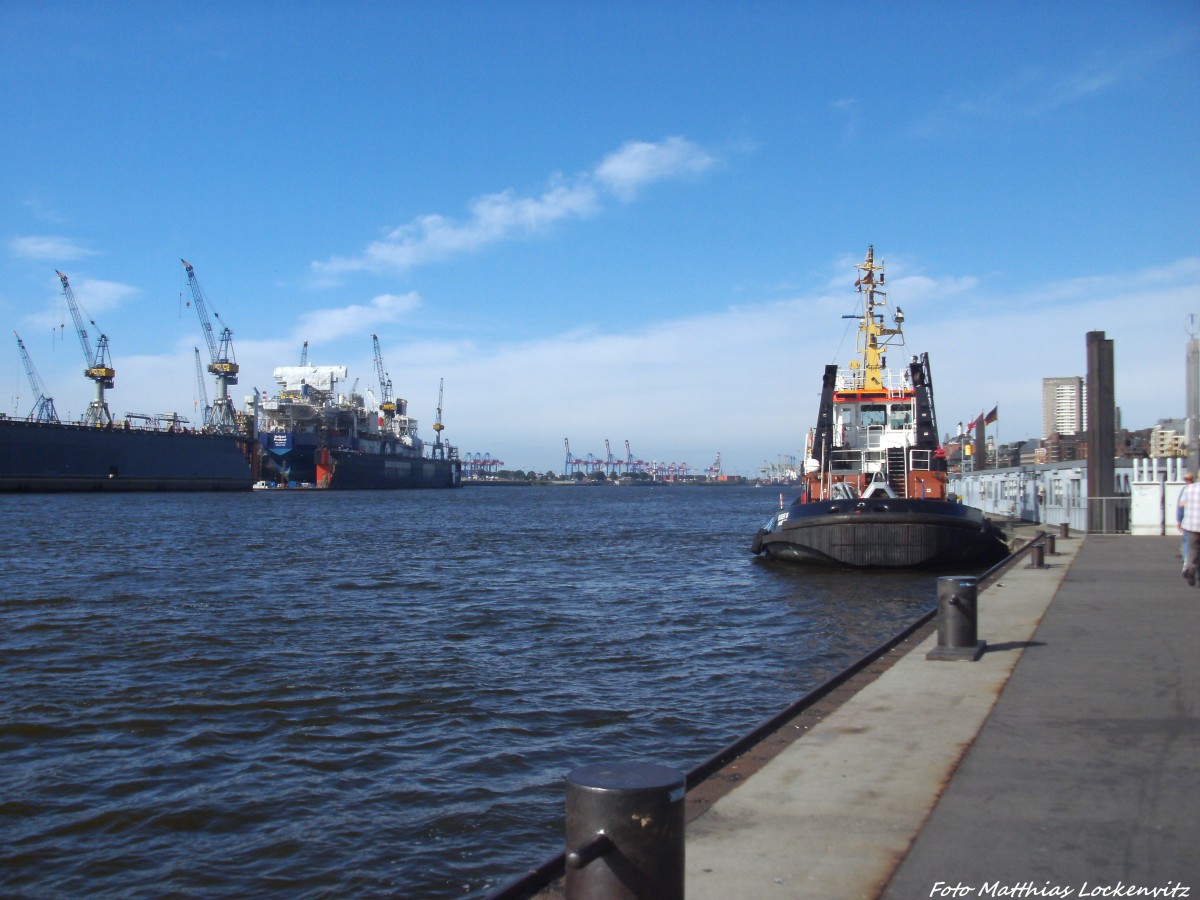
[751,498,1008,569]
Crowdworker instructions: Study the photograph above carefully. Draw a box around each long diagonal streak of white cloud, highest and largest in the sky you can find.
[312,137,714,281]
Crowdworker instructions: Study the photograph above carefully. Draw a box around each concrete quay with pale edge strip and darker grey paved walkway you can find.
[685,535,1200,900]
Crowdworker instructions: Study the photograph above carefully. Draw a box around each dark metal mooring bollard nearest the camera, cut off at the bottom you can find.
[566,762,686,900]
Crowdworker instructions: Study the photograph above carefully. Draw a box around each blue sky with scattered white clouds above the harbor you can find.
[0,0,1200,474]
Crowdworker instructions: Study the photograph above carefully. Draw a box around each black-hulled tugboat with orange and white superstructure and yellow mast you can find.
[751,247,1008,569]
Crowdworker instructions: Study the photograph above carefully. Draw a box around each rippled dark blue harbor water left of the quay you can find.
[0,486,936,898]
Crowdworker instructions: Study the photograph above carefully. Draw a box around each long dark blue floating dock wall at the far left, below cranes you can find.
[0,419,253,493]
